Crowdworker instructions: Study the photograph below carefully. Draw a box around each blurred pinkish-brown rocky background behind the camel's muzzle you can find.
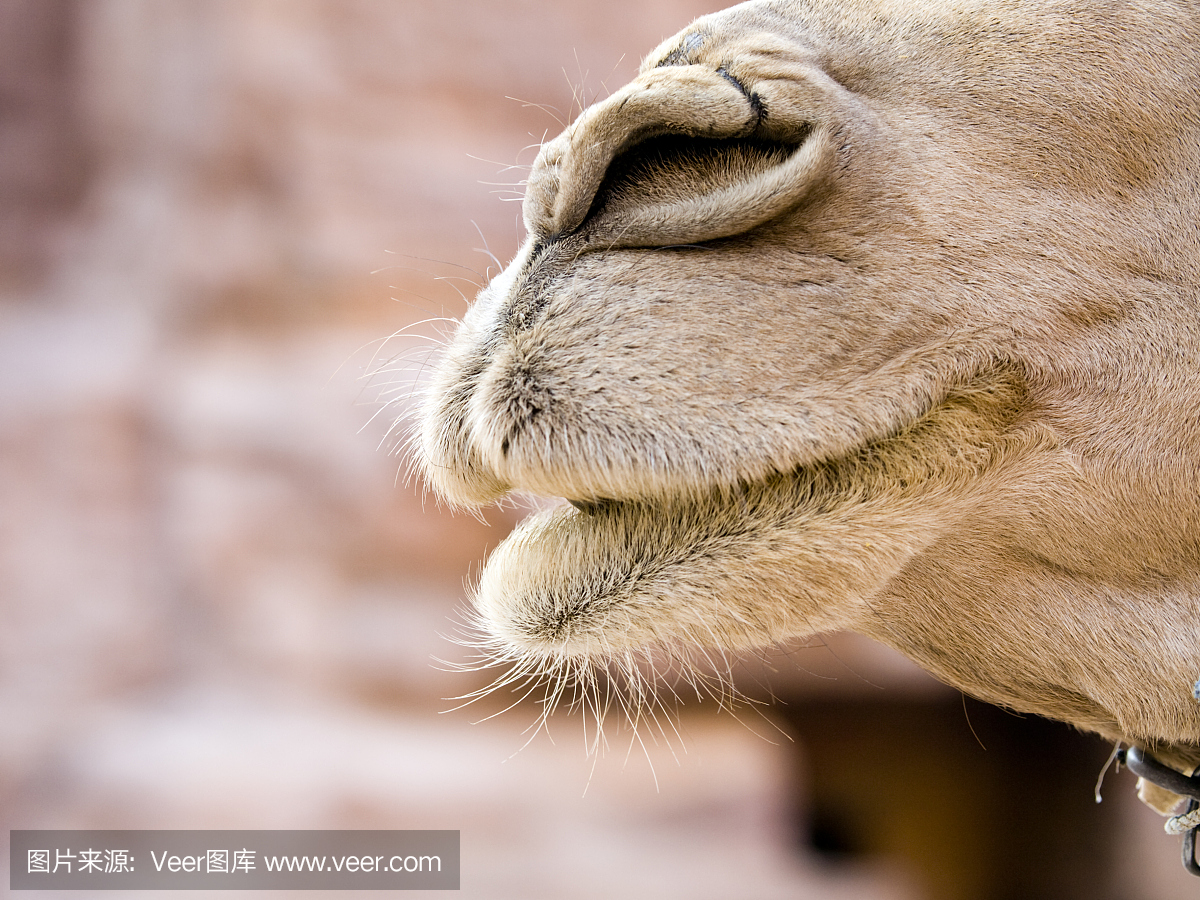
[0,0,1194,900]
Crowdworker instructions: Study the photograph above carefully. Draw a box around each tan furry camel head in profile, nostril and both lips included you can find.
[420,0,1200,761]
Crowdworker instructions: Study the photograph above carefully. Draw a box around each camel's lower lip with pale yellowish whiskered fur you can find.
[474,373,1022,660]
